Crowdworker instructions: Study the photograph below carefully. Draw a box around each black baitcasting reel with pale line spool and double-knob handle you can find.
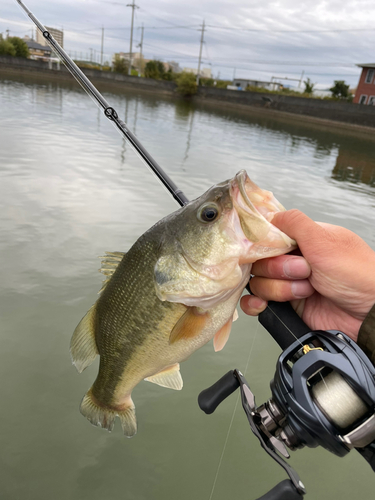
[198,303,375,500]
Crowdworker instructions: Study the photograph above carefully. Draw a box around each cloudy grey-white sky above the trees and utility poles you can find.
[0,0,375,89]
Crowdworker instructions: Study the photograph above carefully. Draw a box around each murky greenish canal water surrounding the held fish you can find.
[0,77,375,500]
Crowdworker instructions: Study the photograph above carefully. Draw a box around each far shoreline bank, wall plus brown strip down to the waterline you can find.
[0,56,375,139]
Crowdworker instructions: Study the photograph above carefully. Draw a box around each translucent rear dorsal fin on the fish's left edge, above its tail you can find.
[70,304,99,373]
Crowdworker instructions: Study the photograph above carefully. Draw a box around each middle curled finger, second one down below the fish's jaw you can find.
[250,276,314,302]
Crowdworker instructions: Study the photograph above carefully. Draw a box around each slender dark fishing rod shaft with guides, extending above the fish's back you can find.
[16,0,189,206]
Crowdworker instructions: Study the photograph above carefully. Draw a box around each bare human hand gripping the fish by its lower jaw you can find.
[241,210,375,341]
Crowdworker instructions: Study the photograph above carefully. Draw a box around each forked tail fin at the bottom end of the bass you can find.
[80,389,137,438]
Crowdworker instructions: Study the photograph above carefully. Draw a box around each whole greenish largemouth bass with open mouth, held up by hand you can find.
[70,170,295,437]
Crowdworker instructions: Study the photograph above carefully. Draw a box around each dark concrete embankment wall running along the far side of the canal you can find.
[0,56,375,129]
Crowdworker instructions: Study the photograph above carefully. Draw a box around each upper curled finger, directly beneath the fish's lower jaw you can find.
[251,255,311,279]
